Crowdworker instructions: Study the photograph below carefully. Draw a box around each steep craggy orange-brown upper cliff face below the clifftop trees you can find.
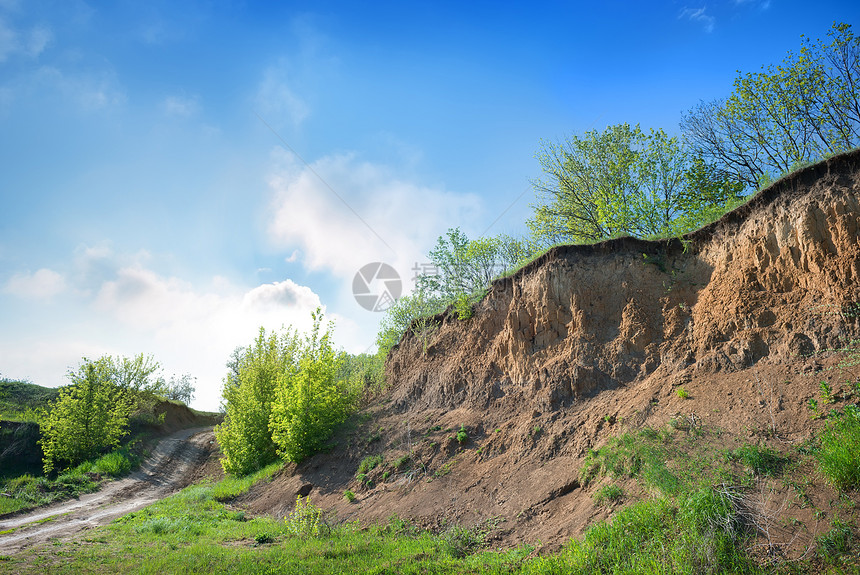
[388,152,860,416]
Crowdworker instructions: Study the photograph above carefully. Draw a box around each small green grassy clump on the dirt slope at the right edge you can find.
[814,406,860,490]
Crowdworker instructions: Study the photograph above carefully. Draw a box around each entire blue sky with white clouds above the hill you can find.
[0,0,860,409]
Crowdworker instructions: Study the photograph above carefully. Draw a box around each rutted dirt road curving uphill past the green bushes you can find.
[0,427,215,555]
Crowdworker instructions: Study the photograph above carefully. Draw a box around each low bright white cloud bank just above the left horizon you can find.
[0,245,326,410]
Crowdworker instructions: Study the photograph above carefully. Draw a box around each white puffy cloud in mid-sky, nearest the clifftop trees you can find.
[269,153,480,288]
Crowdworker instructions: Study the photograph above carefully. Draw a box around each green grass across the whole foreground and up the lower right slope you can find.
[0,410,860,574]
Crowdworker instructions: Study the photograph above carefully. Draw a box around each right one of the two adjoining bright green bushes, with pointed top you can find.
[269,309,358,462]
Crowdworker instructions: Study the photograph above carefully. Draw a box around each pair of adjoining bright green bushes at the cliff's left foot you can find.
[215,309,362,475]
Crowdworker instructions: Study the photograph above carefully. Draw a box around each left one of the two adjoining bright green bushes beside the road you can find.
[215,328,301,475]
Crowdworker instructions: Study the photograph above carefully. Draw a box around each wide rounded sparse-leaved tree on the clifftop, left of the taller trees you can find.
[527,124,743,245]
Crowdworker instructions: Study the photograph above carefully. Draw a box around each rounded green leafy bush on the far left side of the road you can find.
[39,358,135,473]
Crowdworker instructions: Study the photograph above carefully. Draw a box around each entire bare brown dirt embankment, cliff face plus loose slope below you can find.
[239,148,860,548]
